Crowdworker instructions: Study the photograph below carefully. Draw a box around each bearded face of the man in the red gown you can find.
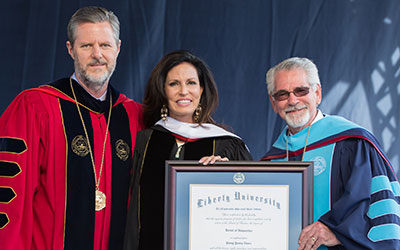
[67,22,121,95]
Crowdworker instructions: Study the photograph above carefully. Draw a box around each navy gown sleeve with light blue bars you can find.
[320,139,400,250]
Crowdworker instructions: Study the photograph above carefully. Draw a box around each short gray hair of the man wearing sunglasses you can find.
[266,57,321,95]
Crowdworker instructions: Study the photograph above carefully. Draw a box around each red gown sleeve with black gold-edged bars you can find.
[0,90,66,250]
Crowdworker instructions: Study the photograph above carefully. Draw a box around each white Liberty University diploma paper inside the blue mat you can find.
[189,184,289,250]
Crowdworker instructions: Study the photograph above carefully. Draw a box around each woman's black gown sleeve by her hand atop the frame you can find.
[215,137,253,161]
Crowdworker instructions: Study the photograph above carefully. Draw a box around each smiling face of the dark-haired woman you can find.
[164,62,203,123]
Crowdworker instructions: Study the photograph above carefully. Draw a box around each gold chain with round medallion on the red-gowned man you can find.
[69,78,112,211]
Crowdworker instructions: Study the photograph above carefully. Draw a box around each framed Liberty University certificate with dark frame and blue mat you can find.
[164,161,313,250]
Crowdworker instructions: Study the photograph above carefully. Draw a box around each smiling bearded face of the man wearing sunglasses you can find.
[269,68,321,134]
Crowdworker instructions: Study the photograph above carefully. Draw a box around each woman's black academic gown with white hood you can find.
[124,117,252,250]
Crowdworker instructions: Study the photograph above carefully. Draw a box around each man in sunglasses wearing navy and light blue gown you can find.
[262,57,400,250]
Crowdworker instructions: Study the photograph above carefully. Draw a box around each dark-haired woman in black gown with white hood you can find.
[124,51,252,250]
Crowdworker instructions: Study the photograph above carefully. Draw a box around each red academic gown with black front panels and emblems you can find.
[0,78,143,250]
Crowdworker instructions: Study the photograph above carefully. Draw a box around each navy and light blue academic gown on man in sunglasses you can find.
[262,116,400,250]
